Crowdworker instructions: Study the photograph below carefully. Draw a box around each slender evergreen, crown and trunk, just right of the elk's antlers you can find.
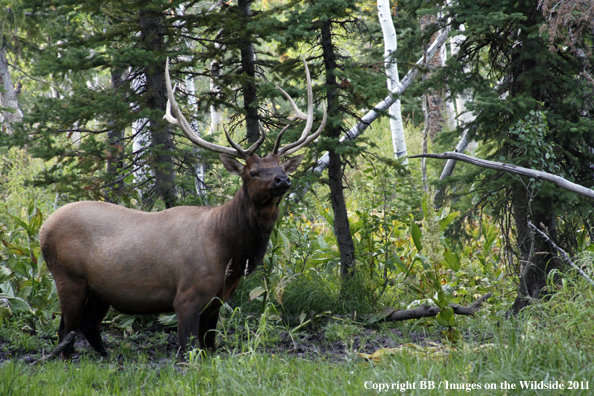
[277,0,385,279]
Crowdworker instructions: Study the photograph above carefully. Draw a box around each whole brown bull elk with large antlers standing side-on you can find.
[40,61,326,357]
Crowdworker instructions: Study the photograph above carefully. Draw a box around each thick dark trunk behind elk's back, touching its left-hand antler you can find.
[139,10,176,208]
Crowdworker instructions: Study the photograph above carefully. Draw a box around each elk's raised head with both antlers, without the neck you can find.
[163,59,327,205]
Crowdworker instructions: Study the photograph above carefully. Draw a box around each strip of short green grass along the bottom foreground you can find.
[0,319,594,395]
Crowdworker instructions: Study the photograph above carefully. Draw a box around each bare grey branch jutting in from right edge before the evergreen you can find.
[409,152,594,199]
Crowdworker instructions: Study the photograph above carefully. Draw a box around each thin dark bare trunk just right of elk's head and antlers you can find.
[321,21,355,279]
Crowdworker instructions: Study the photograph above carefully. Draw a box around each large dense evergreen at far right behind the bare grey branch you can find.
[414,0,594,312]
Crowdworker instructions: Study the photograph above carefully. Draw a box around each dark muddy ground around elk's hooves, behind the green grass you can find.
[0,318,448,366]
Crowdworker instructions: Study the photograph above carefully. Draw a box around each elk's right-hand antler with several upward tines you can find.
[272,59,327,157]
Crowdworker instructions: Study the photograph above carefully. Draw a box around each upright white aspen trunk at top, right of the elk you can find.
[377,0,408,165]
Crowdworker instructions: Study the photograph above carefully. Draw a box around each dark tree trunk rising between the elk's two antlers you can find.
[238,0,260,143]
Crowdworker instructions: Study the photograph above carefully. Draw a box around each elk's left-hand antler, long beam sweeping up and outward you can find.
[163,58,248,159]
